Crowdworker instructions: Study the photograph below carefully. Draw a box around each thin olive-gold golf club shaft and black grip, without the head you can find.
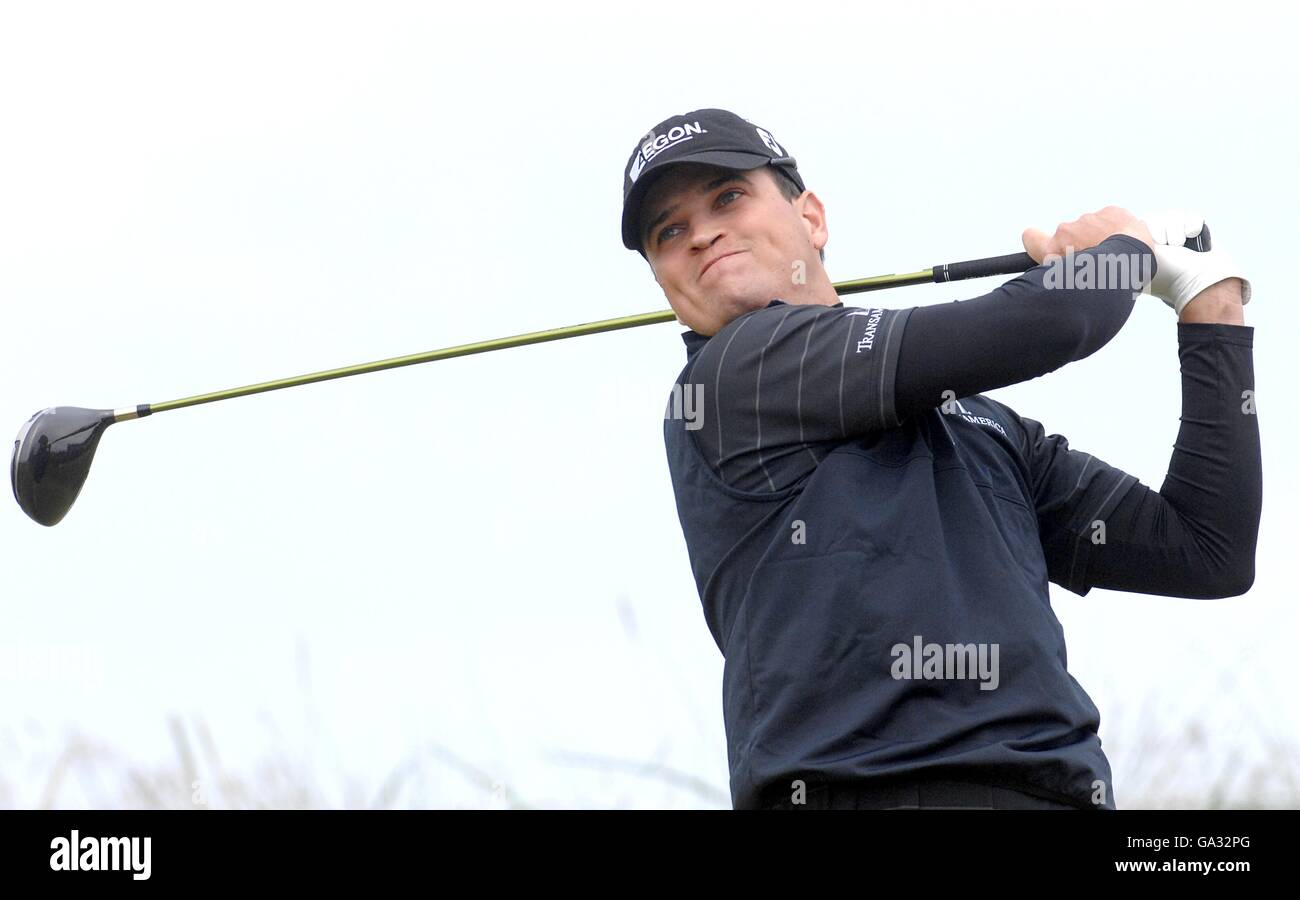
[113,254,1037,421]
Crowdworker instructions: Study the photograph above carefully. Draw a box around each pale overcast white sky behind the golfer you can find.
[0,1,1300,808]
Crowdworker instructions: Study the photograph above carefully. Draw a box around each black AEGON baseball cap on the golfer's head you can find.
[623,109,806,256]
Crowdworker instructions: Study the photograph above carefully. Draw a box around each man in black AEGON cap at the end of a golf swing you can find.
[623,109,1262,809]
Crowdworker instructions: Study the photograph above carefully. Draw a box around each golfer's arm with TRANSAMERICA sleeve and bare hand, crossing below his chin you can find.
[685,207,1156,493]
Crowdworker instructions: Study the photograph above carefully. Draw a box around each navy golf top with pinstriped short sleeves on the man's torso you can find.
[664,300,1138,809]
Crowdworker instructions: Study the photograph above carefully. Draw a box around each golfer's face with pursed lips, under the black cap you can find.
[641,163,827,336]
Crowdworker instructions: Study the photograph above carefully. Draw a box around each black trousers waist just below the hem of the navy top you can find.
[762,779,1080,809]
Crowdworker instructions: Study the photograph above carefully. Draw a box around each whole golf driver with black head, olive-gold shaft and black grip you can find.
[9,235,1209,525]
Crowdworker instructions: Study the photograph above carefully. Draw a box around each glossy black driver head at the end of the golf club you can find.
[9,406,114,525]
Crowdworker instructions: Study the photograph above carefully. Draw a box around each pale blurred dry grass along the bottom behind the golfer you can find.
[0,632,1300,809]
